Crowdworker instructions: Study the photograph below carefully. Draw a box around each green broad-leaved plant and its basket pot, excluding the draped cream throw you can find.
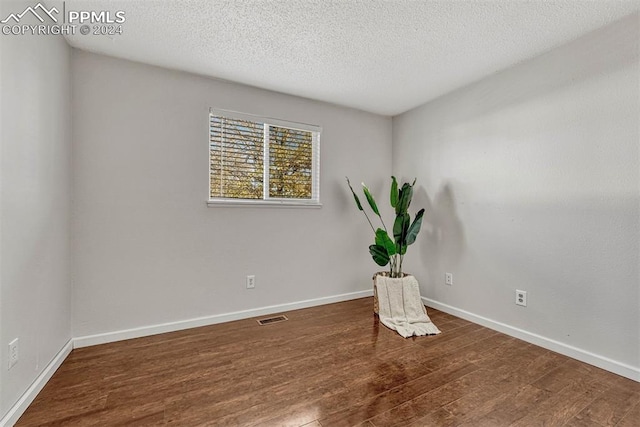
[347,176,424,314]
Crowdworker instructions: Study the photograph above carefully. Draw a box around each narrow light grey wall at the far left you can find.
[0,1,71,418]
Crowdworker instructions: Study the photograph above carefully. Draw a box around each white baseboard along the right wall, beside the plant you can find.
[422,297,640,382]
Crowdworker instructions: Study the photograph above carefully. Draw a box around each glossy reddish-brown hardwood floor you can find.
[17,298,640,427]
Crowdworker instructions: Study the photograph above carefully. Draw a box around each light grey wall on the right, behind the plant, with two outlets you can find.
[393,14,640,378]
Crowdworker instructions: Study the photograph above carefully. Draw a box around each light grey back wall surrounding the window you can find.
[73,51,391,337]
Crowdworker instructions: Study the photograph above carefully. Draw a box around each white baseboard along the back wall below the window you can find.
[73,290,373,348]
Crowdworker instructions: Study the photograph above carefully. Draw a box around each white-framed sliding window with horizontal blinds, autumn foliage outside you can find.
[209,109,321,206]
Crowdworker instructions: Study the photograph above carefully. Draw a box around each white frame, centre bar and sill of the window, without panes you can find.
[207,107,322,208]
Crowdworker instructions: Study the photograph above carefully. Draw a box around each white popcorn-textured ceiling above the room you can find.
[55,0,640,115]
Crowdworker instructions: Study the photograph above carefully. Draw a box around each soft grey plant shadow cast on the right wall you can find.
[417,182,465,283]
